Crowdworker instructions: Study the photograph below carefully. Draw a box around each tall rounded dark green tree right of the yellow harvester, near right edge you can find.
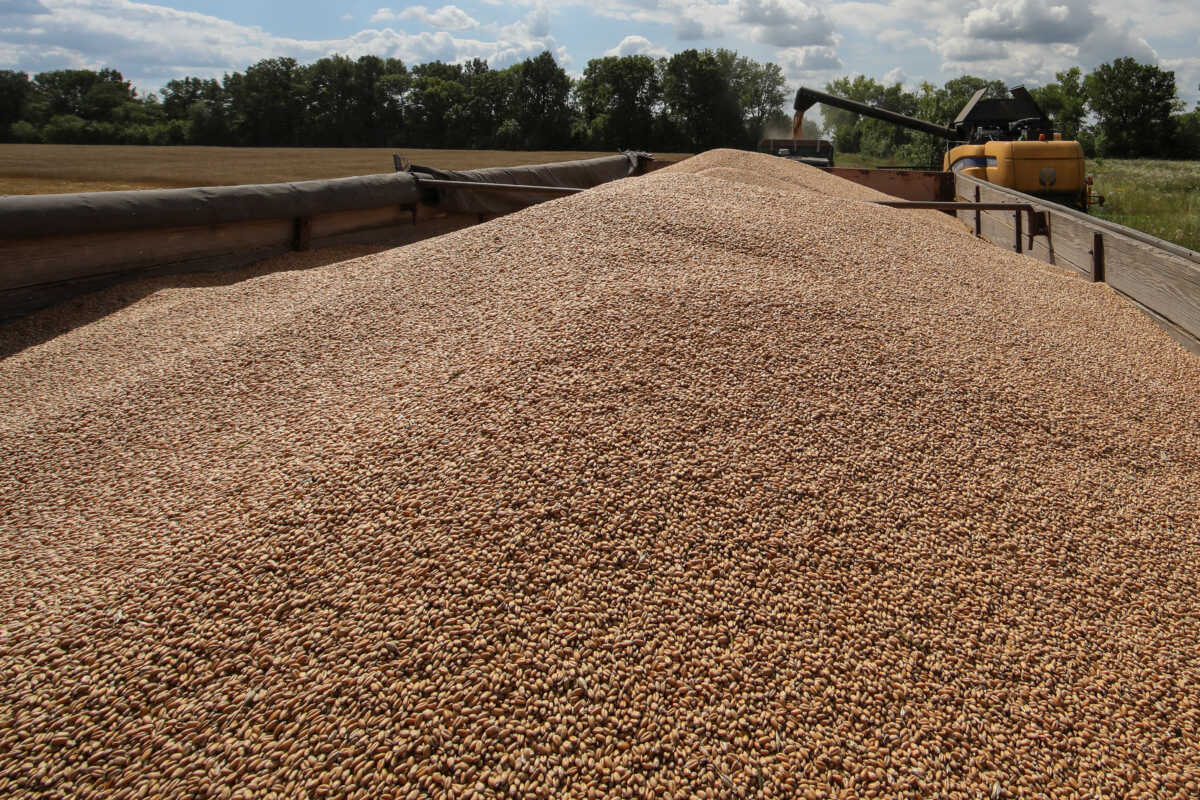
[1084,58,1182,157]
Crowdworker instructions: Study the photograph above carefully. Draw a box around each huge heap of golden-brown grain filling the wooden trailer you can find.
[0,152,1200,799]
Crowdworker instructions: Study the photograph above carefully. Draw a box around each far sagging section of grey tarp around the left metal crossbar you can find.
[409,151,652,215]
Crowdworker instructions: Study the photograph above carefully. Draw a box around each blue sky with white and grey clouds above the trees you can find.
[0,0,1200,109]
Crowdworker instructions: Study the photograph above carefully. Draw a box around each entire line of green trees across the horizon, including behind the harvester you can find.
[0,49,1200,158]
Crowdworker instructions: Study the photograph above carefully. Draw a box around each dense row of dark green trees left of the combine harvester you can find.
[0,49,786,151]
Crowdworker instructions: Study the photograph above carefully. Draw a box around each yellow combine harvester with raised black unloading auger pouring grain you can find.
[793,86,1103,211]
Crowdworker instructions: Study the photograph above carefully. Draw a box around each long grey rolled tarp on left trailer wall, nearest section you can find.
[0,173,420,239]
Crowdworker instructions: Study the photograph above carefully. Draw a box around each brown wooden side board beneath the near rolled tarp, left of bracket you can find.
[0,218,295,290]
